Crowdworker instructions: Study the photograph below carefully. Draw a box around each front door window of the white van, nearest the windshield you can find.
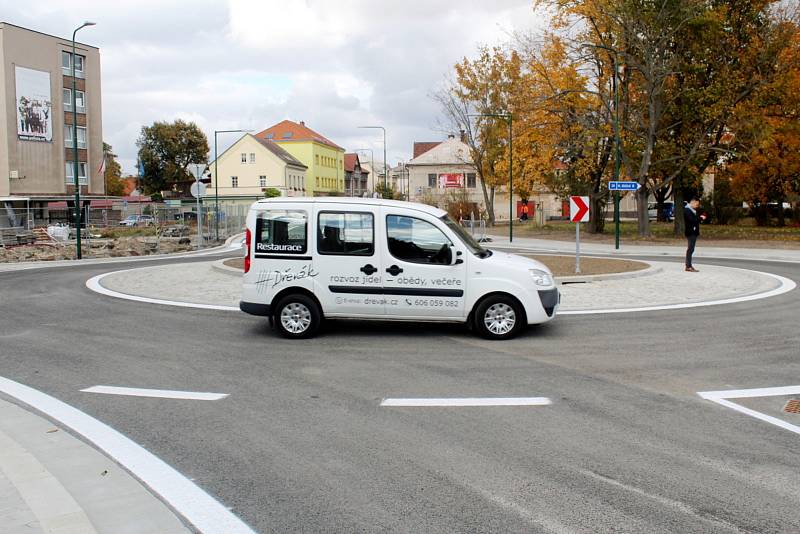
[386,215,451,265]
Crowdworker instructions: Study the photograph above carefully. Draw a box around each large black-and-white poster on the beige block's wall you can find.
[16,66,53,142]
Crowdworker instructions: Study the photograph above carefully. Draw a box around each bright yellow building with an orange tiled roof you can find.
[256,120,344,196]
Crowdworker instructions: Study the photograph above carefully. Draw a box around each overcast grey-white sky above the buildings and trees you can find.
[0,0,542,172]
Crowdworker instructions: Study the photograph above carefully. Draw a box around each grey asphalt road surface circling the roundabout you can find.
[0,257,800,533]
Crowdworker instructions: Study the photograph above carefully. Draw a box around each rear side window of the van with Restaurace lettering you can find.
[255,210,308,254]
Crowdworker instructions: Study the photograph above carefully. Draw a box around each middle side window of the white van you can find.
[317,212,375,256]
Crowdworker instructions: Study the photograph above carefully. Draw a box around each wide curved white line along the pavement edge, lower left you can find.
[0,377,255,534]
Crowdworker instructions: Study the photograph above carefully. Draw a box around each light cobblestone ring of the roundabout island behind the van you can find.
[94,262,780,311]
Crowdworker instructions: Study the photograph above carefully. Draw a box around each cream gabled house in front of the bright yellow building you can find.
[203,134,308,204]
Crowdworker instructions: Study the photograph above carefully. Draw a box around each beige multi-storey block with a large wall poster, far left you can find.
[0,22,105,223]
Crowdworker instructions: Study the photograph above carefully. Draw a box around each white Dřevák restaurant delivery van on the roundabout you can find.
[240,197,560,339]
